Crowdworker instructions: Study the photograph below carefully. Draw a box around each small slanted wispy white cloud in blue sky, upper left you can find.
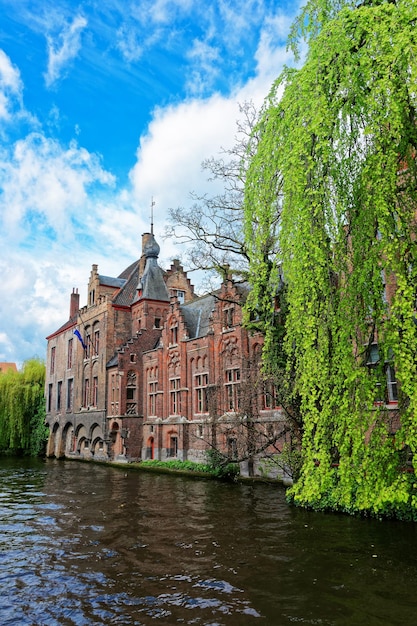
[45,15,87,87]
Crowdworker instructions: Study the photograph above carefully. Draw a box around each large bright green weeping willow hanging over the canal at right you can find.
[245,0,417,519]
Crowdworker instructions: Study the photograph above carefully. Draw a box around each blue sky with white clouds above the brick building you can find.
[0,0,299,367]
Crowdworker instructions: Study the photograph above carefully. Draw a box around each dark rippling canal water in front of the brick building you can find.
[0,459,417,626]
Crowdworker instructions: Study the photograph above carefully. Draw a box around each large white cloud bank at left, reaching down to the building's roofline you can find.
[0,132,131,361]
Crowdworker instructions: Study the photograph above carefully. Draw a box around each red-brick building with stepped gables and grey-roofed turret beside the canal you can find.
[46,233,284,473]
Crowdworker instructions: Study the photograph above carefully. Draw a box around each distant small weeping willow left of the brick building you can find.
[0,359,48,456]
